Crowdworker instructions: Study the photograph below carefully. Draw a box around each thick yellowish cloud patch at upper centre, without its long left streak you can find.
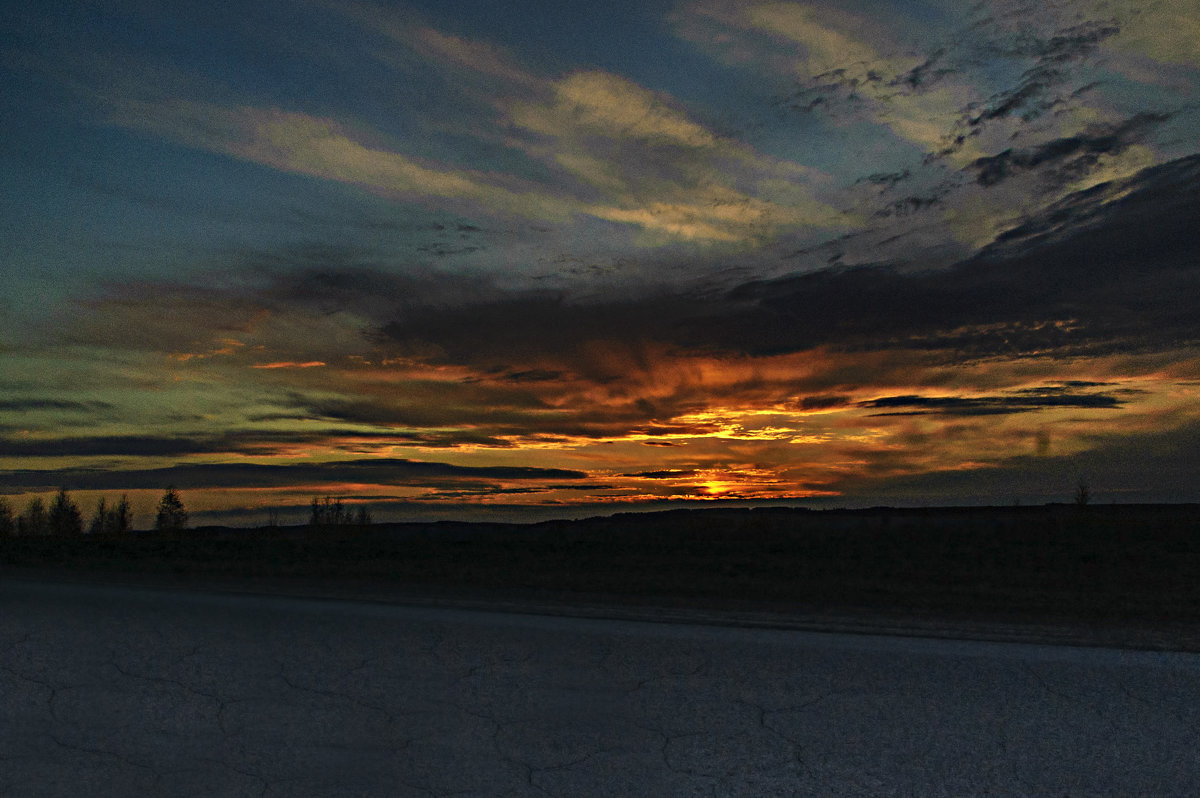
[497,71,853,242]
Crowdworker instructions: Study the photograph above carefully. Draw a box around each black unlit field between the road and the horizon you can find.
[0,505,1200,650]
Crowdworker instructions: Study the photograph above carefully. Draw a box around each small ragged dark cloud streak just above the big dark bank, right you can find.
[968,113,1171,186]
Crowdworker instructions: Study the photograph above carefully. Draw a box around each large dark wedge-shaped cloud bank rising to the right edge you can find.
[705,151,1200,356]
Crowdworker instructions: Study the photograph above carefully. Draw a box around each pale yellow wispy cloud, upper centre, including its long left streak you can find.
[91,6,853,246]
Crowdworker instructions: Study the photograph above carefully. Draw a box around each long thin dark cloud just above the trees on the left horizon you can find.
[0,458,587,490]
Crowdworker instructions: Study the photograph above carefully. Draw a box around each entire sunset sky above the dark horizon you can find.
[0,0,1200,526]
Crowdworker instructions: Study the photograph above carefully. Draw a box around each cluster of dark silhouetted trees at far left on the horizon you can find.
[0,487,187,538]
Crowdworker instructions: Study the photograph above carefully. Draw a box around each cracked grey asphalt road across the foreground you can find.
[0,581,1200,798]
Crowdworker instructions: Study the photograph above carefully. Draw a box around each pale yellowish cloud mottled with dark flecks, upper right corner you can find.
[672,0,1194,255]
